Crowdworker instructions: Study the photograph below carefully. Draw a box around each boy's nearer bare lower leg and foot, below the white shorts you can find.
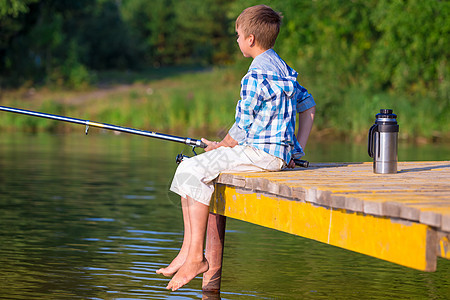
[166,197,209,291]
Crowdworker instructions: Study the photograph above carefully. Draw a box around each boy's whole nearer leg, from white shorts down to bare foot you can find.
[166,146,283,291]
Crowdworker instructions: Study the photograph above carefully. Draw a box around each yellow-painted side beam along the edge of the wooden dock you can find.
[210,184,440,271]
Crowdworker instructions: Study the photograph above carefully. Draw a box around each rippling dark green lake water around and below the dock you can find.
[0,134,450,299]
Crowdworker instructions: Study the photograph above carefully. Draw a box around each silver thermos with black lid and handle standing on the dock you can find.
[368,109,398,174]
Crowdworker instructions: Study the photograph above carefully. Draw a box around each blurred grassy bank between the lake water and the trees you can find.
[0,67,450,142]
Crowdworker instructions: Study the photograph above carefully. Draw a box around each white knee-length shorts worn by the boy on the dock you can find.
[170,145,284,206]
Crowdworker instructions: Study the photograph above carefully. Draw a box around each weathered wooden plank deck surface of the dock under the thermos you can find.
[218,161,450,231]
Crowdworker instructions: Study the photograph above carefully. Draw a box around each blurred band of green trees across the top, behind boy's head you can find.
[0,0,450,98]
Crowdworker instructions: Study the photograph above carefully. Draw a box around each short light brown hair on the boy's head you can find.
[236,5,283,49]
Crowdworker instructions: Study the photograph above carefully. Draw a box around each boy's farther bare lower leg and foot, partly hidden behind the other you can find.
[156,197,191,276]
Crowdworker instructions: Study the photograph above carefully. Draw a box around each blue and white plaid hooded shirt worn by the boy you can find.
[229,49,315,163]
